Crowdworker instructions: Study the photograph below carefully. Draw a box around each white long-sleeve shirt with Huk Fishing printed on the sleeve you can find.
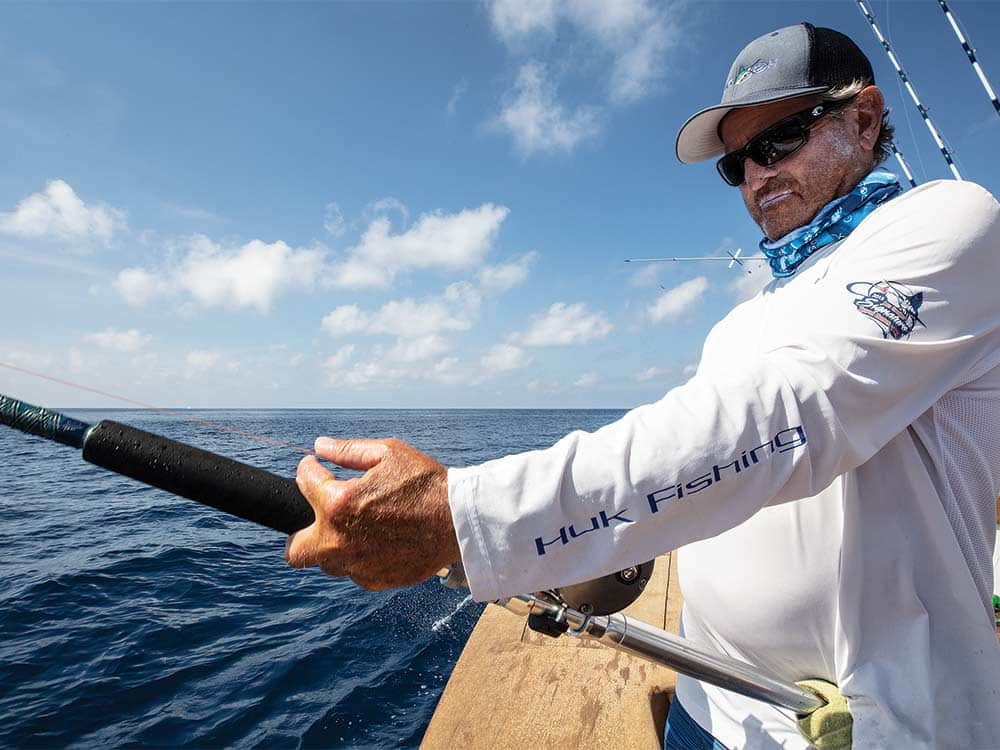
[449,181,1000,748]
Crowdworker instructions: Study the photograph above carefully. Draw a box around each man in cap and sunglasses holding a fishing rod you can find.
[286,23,1000,748]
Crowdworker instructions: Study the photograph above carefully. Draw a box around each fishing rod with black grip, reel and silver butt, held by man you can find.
[0,394,825,714]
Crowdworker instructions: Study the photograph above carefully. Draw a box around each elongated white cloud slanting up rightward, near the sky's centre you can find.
[332,203,508,288]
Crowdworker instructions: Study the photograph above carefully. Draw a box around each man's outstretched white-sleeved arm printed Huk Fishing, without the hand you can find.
[449,183,1000,599]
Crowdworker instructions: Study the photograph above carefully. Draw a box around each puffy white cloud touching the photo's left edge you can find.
[0,180,126,244]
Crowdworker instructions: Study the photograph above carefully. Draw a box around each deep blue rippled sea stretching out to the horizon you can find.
[0,410,622,748]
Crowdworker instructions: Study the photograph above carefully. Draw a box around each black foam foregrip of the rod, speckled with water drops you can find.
[83,420,314,534]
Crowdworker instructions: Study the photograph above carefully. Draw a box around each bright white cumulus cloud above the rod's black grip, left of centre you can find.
[114,236,324,314]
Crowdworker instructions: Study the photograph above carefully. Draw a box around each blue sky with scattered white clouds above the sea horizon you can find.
[0,0,1000,408]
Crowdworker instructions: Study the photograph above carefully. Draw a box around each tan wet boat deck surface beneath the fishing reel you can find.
[421,554,682,750]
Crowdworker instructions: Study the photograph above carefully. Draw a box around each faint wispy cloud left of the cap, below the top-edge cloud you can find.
[497,62,600,156]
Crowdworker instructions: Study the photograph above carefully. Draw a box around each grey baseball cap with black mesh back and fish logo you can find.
[675,23,875,164]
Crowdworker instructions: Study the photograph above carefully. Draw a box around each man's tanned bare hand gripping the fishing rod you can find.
[285,438,461,590]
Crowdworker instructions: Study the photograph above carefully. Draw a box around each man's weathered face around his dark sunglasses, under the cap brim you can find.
[720,93,881,240]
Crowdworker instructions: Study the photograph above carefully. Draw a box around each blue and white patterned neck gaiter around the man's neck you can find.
[760,169,902,279]
